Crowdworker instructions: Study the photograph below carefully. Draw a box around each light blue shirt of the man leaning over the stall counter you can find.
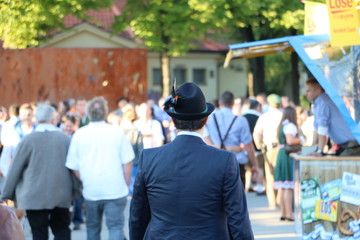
[314,93,356,144]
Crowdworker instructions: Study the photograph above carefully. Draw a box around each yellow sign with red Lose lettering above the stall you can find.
[326,0,360,46]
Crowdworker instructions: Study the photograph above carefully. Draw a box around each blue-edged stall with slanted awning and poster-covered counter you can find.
[227,35,360,240]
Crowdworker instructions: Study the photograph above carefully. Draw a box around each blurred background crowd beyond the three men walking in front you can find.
[0,91,316,238]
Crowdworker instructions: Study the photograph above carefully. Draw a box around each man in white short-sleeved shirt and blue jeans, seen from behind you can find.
[66,97,134,240]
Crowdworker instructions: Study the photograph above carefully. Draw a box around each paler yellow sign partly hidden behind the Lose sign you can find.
[304,1,330,35]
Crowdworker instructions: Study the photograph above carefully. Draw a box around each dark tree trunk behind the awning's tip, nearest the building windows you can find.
[239,26,266,95]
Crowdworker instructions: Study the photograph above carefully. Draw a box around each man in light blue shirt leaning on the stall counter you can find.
[306,78,360,156]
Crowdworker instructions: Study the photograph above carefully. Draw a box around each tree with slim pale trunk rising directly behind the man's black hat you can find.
[113,0,208,96]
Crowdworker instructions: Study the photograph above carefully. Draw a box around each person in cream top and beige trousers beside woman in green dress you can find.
[253,94,282,209]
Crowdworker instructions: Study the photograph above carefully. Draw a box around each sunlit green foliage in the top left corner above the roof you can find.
[0,0,112,48]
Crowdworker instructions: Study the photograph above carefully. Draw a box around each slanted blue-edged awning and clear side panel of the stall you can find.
[225,34,360,142]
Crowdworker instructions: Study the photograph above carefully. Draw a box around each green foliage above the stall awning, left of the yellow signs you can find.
[189,0,304,40]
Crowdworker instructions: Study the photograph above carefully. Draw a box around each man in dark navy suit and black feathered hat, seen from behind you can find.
[129,83,254,240]
